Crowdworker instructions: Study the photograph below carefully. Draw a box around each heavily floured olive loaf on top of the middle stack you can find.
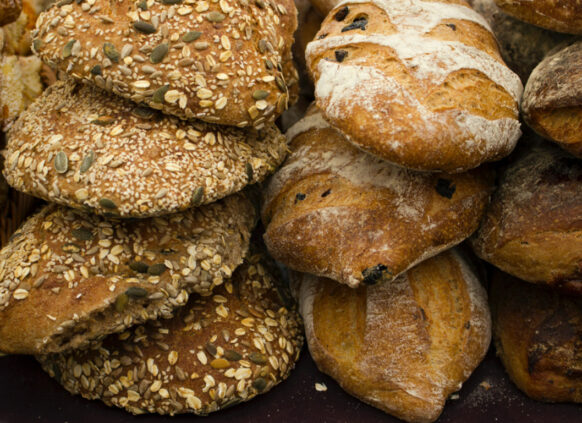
[306,0,522,172]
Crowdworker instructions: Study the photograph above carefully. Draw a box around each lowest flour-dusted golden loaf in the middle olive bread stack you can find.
[295,250,491,422]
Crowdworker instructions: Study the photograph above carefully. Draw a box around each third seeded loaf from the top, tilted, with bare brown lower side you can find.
[0,194,255,354]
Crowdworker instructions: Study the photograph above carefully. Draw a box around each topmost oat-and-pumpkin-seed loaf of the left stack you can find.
[33,0,297,128]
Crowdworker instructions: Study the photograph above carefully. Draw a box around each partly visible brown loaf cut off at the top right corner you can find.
[495,0,582,34]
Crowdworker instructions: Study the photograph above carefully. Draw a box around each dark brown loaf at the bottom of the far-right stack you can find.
[491,271,582,403]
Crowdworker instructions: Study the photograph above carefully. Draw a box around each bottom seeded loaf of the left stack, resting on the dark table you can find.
[38,256,303,415]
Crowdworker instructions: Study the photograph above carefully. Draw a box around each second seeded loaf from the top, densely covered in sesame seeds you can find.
[4,81,287,217]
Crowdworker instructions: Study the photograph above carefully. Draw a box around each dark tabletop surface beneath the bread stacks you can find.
[0,350,582,423]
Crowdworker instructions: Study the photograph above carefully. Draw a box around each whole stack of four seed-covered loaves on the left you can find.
[0,0,303,414]
